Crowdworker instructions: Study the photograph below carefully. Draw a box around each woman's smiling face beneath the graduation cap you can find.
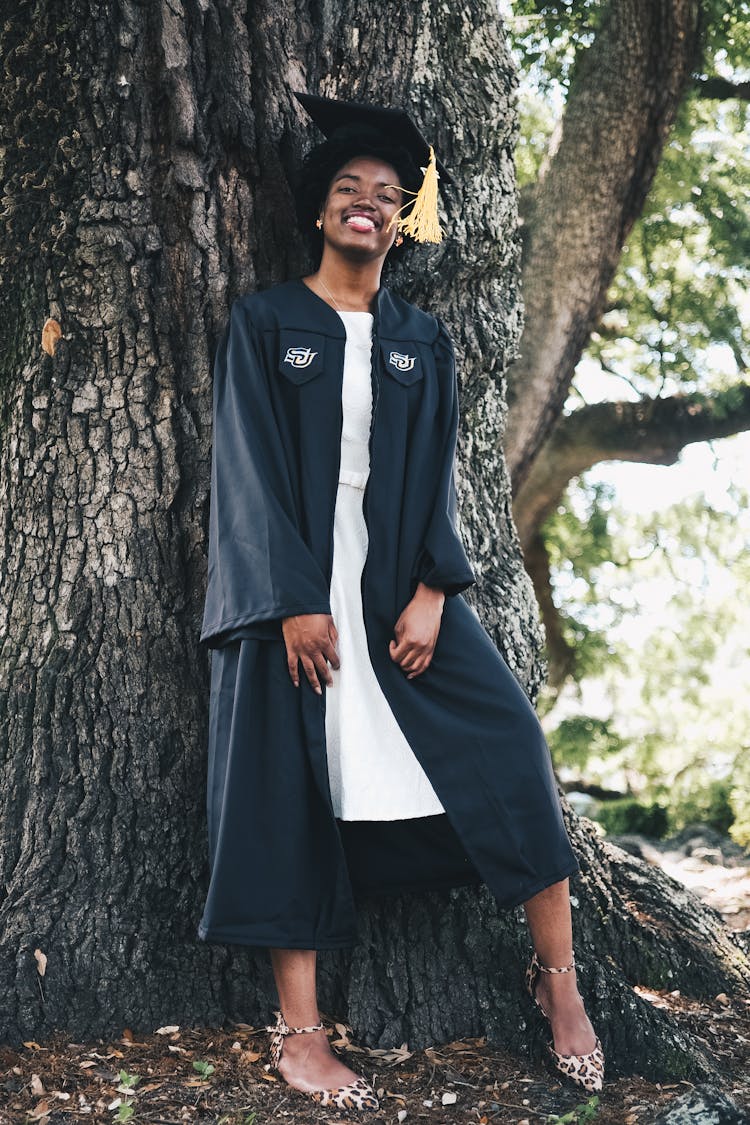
[320,156,405,259]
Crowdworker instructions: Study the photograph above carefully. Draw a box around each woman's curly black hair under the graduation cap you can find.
[292,125,423,261]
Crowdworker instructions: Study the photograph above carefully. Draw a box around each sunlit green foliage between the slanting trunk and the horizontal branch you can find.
[587,90,750,397]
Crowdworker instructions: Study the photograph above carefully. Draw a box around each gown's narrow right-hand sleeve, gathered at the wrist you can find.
[413,318,477,597]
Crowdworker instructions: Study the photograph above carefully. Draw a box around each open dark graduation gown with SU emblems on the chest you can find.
[198,280,578,950]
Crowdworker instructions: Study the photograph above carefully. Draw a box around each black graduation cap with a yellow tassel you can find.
[292,90,452,242]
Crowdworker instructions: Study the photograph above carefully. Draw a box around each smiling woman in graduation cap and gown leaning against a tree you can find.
[198,95,604,1109]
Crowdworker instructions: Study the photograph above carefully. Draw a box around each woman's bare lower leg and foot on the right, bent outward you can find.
[524,879,596,1054]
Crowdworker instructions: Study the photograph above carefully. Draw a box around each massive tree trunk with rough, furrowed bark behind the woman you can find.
[0,0,749,1076]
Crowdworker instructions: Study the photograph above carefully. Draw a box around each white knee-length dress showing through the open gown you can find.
[324,312,445,820]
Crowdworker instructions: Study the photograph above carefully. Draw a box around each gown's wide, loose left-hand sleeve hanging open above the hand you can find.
[200,299,331,648]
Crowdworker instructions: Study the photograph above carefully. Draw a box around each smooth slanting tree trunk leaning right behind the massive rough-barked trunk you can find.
[505,0,701,492]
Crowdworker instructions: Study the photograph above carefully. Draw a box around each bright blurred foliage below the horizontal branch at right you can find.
[548,482,750,843]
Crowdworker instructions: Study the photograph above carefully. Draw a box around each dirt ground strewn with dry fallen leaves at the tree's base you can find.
[0,991,750,1125]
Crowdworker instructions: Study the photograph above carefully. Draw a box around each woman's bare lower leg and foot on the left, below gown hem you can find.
[269,950,368,1090]
